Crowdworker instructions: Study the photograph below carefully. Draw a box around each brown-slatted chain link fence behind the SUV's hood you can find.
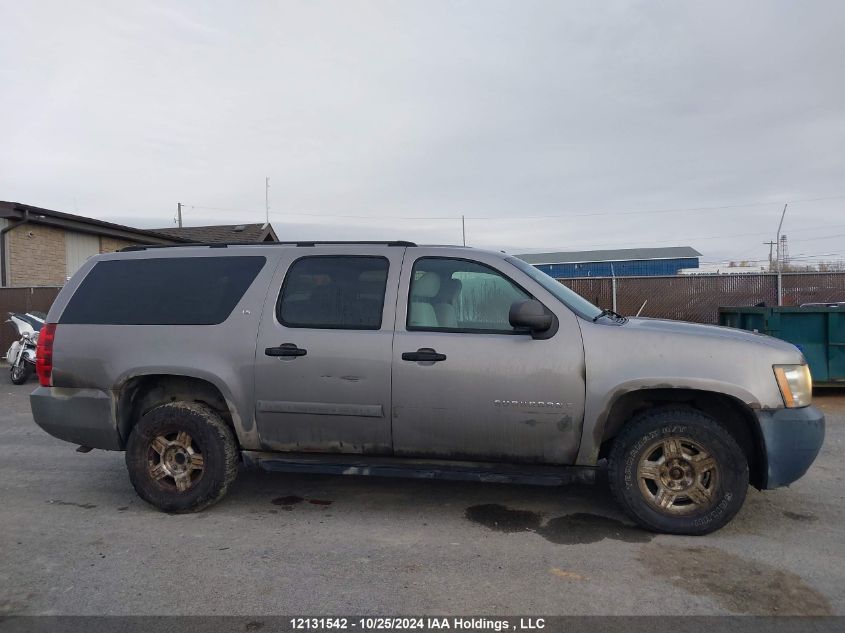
[558,272,845,324]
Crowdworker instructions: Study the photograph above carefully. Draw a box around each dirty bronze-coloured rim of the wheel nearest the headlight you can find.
[637,436,720,516]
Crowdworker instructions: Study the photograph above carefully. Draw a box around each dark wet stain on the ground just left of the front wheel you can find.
[466,503,654,545]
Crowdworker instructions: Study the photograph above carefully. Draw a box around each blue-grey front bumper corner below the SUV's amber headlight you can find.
[757,406,824,489]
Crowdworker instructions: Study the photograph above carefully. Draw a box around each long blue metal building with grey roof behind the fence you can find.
[517,246,701,278]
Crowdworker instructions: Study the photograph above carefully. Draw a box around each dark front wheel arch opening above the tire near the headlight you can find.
[599,388,767,488]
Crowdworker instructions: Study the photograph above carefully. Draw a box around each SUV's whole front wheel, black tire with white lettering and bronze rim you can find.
[608,407,748,535]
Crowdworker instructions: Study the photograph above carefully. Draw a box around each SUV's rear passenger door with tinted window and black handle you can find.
[255,246,405,454]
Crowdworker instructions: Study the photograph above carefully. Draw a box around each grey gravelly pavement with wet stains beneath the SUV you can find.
[0,376,845,615]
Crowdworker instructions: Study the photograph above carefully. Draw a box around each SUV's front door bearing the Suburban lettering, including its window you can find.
[393,248,584,464]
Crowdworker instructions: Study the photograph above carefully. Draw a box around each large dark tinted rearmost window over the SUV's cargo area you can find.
[59,256,267,325]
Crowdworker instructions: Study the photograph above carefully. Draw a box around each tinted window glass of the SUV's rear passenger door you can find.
[276,255,388,330]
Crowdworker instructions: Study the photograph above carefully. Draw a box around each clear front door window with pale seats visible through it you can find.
[407,257,532,334]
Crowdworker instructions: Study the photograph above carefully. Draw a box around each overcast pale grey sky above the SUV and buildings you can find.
[0,0,845,261]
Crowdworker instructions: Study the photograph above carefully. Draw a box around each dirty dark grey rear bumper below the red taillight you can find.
[29,387,123,451]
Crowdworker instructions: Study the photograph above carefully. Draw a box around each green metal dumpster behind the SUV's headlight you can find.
[719,304,845,386]
